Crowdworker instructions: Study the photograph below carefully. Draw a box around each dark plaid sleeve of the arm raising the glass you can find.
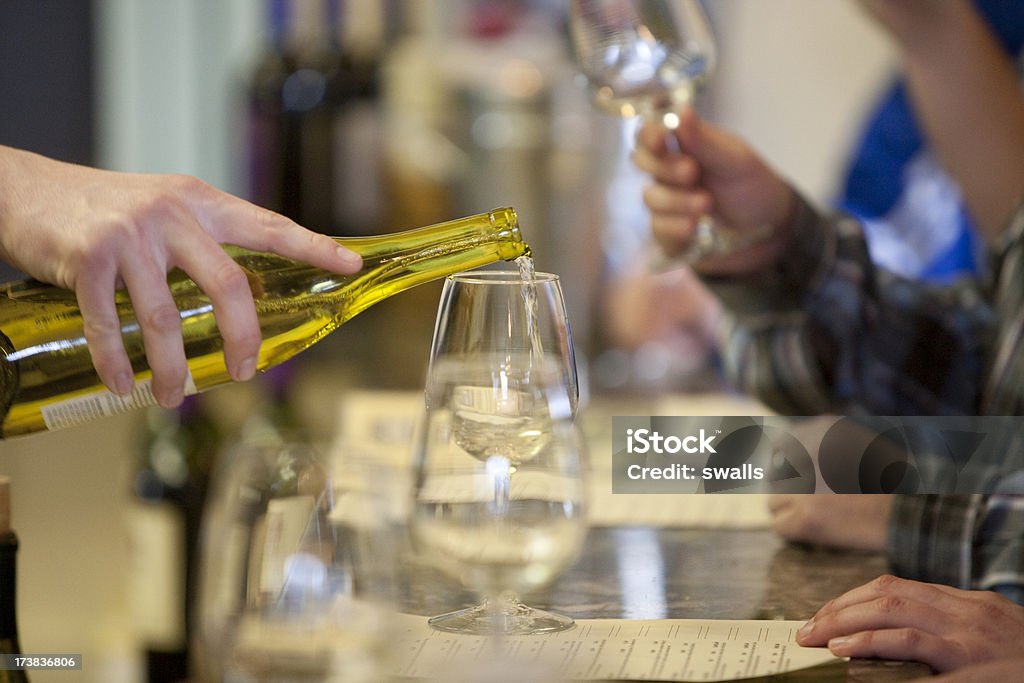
[708,193,991,415]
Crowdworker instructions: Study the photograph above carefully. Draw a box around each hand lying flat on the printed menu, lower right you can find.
[797,575,1024,680]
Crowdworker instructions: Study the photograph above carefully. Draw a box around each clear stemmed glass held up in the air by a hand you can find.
[568,0,767,262]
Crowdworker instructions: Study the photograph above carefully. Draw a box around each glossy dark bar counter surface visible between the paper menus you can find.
[393,526,932,683]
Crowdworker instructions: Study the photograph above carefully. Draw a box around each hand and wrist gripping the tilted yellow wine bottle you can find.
[0,147,361,408]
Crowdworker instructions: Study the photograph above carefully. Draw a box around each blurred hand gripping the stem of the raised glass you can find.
[633,106,797,274]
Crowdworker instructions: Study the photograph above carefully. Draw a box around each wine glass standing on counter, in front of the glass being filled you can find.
[411,356,586,635]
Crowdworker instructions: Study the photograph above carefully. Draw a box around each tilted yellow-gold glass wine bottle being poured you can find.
[0,208,529,438]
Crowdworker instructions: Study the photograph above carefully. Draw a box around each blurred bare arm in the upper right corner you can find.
[860,0,1024,240]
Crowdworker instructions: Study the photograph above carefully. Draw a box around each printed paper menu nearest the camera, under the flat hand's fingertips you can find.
[393,615,844,681]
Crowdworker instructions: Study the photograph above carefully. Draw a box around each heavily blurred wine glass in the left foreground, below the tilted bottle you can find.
[195,437,408,683]
